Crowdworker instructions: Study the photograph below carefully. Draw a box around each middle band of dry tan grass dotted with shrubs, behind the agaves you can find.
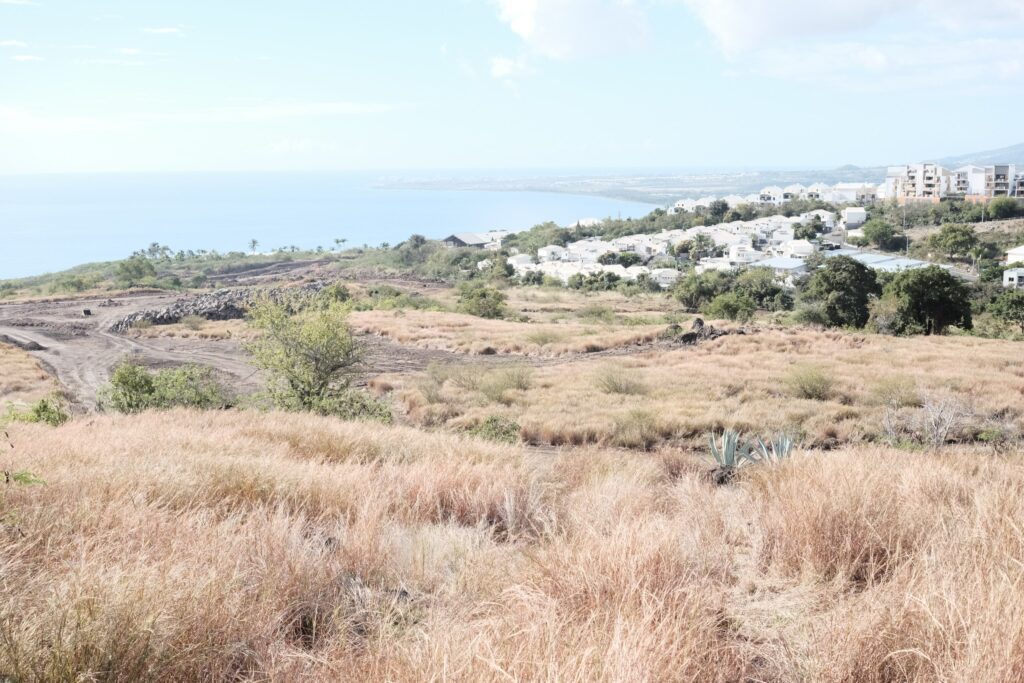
[391,323,1024,447]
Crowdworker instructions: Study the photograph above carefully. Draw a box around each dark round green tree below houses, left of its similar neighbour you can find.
[803,256,882,328]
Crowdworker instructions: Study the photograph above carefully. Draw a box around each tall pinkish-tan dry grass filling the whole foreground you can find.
[6,409,1024,682]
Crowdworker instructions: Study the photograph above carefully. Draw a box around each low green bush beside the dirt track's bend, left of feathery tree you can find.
[98,360,229,414]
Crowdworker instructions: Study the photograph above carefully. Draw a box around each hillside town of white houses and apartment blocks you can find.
[443,164,1024,289]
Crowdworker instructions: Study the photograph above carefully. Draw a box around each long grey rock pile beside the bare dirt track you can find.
[111,282,327,333]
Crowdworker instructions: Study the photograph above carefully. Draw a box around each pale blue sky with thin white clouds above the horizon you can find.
[0,0,1024,174]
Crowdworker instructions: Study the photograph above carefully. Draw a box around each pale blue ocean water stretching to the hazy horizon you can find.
[0,173,654,280]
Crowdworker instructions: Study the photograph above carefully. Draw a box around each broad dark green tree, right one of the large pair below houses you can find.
[884,265,973,335]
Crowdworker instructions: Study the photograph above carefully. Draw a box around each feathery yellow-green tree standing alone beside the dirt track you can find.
[246,300,359,413]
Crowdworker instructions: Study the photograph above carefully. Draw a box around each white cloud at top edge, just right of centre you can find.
[497,0,649,59]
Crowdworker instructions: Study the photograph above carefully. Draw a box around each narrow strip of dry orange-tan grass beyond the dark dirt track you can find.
[349,310,666,355]
